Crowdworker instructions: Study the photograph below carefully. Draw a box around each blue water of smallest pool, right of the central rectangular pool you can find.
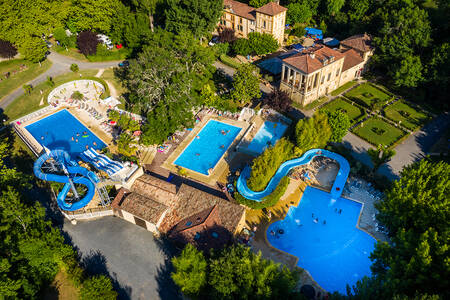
[247,121,287,155]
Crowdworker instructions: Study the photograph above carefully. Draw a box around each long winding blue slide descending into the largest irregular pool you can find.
[236,149,350,202]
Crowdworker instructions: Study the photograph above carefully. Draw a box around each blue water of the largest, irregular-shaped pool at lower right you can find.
[267,187,376,294]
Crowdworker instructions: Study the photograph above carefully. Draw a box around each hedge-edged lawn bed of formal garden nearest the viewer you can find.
[353,117,405,147]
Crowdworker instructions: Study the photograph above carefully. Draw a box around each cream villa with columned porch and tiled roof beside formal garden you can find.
[280,34,373,106]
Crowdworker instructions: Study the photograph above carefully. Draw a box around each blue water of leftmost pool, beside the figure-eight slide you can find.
[25,109,106,159]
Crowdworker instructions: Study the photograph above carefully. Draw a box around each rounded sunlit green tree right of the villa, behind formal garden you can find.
[390,55,424,87]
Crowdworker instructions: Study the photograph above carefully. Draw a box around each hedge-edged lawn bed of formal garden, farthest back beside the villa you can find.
[345,83,392,110]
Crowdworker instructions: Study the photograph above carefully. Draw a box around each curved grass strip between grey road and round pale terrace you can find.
[4,70,104,121]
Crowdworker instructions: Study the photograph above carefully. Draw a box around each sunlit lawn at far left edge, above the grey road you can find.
[0,59,52,99]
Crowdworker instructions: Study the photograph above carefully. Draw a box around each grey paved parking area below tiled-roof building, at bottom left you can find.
[63,216,180,300]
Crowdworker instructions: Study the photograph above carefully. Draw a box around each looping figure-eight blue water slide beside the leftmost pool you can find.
[33,150,99,211]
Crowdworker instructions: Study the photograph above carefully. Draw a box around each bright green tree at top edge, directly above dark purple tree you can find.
[69,0,121,34]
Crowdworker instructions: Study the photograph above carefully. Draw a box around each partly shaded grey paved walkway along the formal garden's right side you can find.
[378,113,450,179]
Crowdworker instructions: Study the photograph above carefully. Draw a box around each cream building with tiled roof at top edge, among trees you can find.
[220,0,287,45]
